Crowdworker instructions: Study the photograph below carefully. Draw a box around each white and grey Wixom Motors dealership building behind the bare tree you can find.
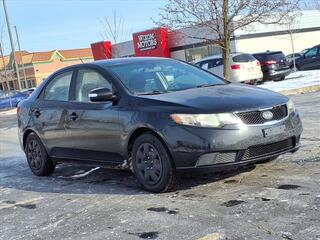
[90,10,320,62]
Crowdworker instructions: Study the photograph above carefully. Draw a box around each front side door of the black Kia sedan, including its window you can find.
[66,68,123,163]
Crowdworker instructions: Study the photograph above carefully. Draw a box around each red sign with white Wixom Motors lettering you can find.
[133,27,170,57]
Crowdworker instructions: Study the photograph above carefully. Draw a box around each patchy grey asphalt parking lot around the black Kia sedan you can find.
[0,92,320,240]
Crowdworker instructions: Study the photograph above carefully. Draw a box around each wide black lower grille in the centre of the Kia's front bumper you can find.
[242,138,294,160]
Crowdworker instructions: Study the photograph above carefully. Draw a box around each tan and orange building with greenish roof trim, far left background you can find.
[0,48,93,90]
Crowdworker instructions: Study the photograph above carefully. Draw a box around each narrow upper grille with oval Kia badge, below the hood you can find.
[237,104,288,124]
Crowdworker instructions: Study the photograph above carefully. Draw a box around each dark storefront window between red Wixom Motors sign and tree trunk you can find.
[185,45,221,62]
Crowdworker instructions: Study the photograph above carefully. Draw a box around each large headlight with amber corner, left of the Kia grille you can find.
[170,113,242,128]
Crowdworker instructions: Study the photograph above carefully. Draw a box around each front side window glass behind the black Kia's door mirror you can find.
[76,69,112,102]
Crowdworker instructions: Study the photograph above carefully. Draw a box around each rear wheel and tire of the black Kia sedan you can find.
[25,133,56,176]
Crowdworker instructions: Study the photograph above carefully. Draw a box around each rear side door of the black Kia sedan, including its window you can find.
[30,69,73,157]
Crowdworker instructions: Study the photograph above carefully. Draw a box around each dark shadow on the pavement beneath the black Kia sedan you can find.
[0,157,254,195]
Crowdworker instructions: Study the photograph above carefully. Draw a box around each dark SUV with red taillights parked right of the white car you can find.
[253,51,291,81]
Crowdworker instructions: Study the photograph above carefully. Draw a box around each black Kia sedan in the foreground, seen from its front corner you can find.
[17,58,302,192]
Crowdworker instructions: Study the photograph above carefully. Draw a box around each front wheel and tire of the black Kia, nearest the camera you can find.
[132,133,175,193]
